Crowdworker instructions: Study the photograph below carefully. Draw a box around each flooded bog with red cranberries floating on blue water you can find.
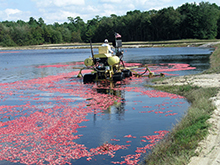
[0,48,213,164]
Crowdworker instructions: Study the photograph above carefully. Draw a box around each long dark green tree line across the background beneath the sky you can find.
[0,2,220,46]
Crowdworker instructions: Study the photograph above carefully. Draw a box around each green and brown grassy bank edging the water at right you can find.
[144,45,220,165]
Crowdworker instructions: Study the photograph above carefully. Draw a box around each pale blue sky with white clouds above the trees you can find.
[0,0,220,24]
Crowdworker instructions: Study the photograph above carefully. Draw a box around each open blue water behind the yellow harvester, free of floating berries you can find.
[0,47,213,82]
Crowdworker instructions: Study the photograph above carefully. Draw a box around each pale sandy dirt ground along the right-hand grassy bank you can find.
[155,74,220,165]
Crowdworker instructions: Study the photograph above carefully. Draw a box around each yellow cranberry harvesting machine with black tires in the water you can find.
[77,34,164,84]
